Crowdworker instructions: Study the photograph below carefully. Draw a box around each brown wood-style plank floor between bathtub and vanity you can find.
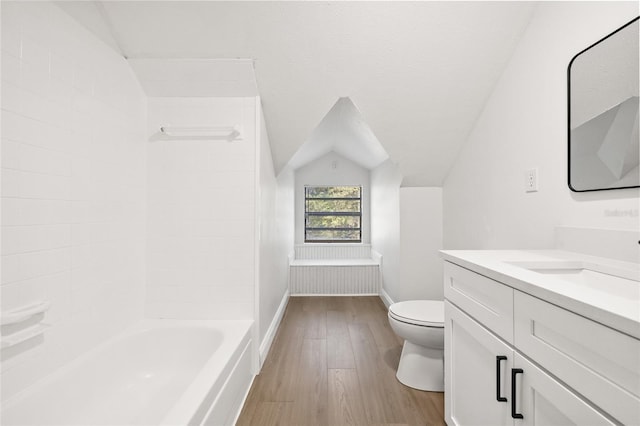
[237,297,445,426]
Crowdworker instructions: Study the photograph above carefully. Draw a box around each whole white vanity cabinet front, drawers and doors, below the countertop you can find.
[444,262,640,426]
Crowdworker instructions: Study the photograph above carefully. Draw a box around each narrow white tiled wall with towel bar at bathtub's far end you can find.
[146,98,257,319]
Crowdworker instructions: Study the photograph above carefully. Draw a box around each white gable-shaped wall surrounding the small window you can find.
[295,152,371,244]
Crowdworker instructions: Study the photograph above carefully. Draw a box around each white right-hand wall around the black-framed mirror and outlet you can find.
[444,2,639,249]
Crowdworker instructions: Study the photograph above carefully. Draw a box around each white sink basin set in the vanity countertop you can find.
[507,261,640,301]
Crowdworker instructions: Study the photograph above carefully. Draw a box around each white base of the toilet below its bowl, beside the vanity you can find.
[396,340,444,392]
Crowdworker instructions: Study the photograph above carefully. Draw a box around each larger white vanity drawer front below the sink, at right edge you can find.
[514,291,640,425]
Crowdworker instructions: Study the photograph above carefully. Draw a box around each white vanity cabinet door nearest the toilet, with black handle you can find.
[444,301,513,426]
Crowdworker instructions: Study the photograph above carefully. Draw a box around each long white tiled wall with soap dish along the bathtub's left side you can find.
[1,2,146,400]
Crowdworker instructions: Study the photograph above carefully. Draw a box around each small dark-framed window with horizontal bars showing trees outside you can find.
[304,186,362,243]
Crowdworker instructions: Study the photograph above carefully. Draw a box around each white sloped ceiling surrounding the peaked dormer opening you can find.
[58,1,534,186]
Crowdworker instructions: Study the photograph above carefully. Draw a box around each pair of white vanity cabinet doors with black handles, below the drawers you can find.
[445,302,615,426]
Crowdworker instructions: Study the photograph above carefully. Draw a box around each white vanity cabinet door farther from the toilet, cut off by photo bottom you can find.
[512,352,616,426]
